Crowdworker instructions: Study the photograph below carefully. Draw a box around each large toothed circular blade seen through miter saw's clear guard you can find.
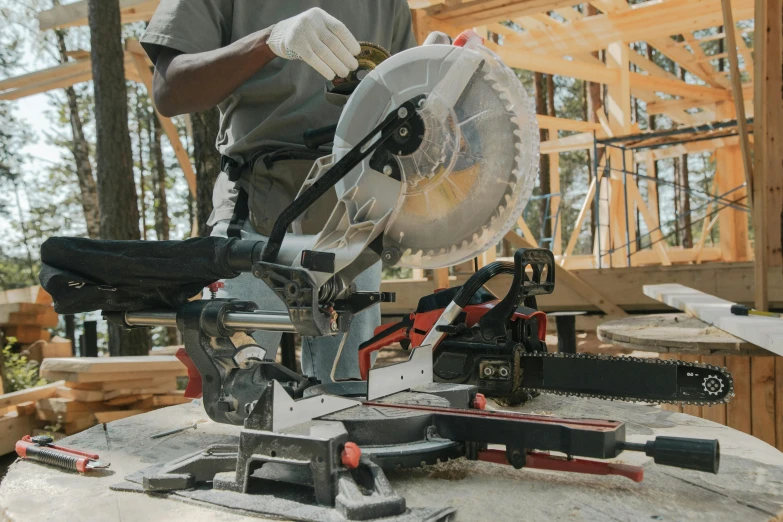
[384,47,540,269]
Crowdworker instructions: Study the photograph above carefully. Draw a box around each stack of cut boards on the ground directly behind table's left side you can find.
[31,356,189,435]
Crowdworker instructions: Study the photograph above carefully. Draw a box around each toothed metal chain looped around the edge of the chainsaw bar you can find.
[519,352,734,406]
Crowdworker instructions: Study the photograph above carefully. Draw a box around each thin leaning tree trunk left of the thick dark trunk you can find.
[55,31,101,239]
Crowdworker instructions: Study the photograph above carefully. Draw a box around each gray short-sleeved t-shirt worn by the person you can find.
[141,0,416,162]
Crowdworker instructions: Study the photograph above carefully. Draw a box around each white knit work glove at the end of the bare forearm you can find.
[267,7,362,80]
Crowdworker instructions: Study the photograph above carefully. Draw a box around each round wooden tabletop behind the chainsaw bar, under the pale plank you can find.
[598,314,774,356]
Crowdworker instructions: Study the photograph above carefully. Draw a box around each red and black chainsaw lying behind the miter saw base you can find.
[359,250,734,406]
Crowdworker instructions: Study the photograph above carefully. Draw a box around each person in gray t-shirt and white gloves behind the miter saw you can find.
[141,0,416,382]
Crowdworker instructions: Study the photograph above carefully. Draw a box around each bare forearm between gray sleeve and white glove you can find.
[153,28,276,117]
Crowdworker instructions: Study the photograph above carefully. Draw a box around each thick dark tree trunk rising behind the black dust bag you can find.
[88,0,151,355]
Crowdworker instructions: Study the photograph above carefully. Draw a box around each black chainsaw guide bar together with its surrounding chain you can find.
[519,352,734,406]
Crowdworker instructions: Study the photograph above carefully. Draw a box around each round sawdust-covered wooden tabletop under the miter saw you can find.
[0,396,783,522]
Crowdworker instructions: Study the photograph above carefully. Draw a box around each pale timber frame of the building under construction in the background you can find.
[0,0,783,316]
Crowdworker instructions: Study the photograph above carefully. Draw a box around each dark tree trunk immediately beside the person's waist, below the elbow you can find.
[190,107,220,237]
